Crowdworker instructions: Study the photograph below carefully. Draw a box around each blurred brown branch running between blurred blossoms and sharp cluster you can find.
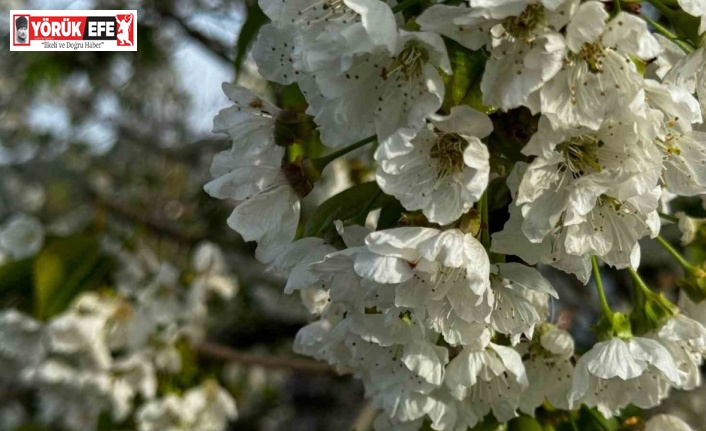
[194,342,336,374]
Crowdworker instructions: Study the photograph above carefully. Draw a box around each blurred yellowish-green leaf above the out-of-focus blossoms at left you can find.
[34,234,112,319]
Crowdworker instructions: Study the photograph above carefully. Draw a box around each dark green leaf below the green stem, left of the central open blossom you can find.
[303,181,394,237]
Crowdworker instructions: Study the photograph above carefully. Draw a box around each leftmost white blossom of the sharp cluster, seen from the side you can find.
[204,85,300,262]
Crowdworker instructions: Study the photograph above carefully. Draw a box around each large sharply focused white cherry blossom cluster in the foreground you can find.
[205,0,706,431]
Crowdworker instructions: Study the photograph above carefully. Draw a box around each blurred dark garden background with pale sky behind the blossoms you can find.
[0,0,706,431]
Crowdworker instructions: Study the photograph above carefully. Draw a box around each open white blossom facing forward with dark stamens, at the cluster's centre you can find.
[375,107,493,225]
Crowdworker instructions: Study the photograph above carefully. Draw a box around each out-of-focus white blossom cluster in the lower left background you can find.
[0,231,237,431]
